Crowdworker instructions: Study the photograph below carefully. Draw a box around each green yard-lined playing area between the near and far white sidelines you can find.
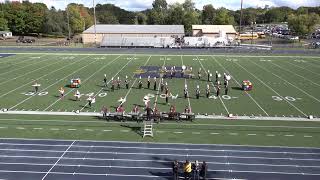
[0,54,320,117]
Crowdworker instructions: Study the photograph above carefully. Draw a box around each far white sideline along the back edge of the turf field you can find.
[0,52,320,59]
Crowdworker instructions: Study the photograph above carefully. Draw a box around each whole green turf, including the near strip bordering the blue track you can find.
[0,53,320,147]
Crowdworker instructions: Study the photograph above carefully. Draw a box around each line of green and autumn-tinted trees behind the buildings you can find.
[0,0,320,36]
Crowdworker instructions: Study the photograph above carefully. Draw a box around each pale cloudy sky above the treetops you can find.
[0,0,320,11]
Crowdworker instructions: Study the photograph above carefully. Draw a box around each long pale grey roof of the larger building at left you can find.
[83,24,184,34]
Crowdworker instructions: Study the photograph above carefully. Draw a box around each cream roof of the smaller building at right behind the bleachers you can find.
[192,25,237,33]
